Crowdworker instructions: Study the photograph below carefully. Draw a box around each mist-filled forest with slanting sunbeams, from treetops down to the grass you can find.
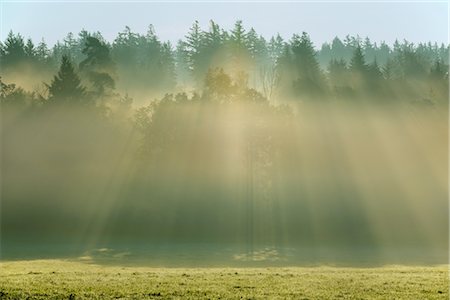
[0,21,449,266]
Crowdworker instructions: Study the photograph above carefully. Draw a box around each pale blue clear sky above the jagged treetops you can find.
[0,0,449,46]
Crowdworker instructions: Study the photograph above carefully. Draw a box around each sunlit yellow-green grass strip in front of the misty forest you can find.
[0,260,449,299]
